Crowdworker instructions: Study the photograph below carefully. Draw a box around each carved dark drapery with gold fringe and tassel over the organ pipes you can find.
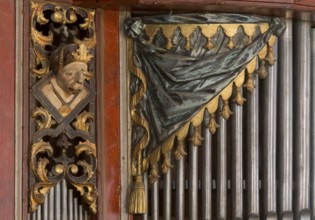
[125,14,284,213]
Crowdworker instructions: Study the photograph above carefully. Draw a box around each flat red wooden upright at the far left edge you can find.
[0,0,15,220]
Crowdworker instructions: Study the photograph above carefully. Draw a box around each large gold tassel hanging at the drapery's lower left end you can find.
[129,175,147,214]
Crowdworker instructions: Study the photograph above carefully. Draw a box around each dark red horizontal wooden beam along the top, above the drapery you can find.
[73,0,315,13]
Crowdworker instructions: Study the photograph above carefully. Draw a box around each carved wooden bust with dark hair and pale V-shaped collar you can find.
[41,44,91,117]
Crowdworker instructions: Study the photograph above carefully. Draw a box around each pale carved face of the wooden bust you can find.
[57,62,88,95]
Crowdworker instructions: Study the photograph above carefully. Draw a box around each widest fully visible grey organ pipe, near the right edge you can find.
[293,16,311,219]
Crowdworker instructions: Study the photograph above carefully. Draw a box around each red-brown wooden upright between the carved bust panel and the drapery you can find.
[99,11,120,220]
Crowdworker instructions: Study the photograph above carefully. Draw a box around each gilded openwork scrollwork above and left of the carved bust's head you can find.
[31,2,96,77]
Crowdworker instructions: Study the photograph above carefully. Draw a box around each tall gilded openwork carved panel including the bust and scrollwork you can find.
[29,3,97,213]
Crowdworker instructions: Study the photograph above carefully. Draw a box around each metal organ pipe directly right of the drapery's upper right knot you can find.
[277,19,293,219]
